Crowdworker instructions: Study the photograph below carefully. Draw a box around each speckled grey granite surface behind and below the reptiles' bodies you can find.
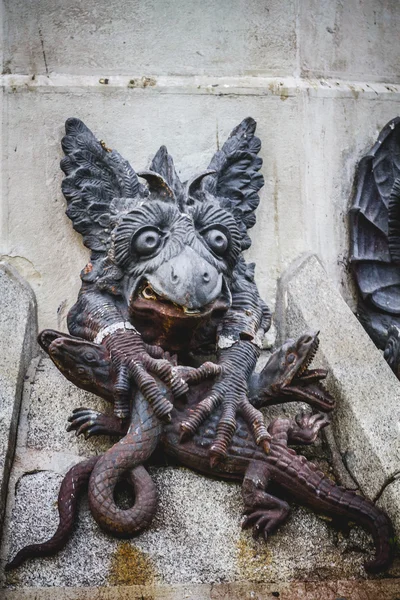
[0,357,398,598]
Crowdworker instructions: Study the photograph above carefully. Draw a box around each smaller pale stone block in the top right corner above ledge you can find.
[299,0,400,82]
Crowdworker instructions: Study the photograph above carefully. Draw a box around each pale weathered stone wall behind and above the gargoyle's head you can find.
[0,0,400,329]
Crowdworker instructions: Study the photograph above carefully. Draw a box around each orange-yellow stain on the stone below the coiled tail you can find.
[108,542,154,585]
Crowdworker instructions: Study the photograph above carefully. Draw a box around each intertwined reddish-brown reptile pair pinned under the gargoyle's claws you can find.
[6,331,393,572]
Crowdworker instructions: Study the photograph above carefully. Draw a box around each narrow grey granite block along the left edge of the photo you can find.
[0,263,38,524]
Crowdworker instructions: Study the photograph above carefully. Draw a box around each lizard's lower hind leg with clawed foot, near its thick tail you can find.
[242,461,290,540]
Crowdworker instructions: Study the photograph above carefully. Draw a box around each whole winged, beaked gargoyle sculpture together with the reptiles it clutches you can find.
[8,118,392,571]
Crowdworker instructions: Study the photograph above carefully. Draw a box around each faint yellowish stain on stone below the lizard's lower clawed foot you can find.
[236,533,272,582]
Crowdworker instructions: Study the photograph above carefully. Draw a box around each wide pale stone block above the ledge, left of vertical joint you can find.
[4,0,296,78]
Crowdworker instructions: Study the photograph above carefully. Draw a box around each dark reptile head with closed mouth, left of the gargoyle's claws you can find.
[38,329,112,399]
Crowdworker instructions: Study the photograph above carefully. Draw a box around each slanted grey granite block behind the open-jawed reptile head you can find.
[277,256,400,514]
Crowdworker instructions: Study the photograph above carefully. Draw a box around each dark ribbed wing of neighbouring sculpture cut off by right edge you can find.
[350,117,400,314]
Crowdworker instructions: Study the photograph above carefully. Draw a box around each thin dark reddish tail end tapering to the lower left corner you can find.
[5,456,100,571]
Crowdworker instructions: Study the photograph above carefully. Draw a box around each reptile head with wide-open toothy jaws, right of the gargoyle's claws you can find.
[260,333,335,411]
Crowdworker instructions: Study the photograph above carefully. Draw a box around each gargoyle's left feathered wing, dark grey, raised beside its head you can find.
[61,118,140,252]
